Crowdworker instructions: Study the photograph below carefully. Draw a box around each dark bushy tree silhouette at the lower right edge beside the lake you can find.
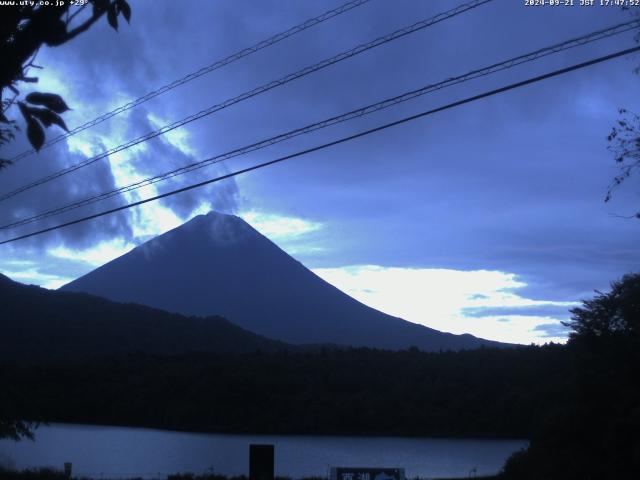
[505,274,640,479]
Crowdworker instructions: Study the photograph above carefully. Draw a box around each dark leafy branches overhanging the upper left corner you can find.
[0,0,131,169]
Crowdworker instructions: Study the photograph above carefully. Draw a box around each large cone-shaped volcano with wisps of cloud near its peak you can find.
[62,212,508,351]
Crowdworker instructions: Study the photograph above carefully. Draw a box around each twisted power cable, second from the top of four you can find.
[0,0,493,201]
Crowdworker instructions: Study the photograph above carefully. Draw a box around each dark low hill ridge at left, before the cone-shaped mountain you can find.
[0,274,292,361]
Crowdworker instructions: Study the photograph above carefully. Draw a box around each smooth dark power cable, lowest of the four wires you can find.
[0,46,640,245]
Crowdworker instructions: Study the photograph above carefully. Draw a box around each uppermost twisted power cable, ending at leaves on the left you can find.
[5,0,370,162]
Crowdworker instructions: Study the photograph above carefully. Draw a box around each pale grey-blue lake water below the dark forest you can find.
[0,424,527,478]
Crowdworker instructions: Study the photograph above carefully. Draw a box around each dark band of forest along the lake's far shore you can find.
[0,346,566,437]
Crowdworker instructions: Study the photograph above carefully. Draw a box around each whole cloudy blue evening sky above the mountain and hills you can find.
[0,0,640,343]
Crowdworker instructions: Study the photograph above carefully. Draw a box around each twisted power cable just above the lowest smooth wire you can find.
[0,20,640,230]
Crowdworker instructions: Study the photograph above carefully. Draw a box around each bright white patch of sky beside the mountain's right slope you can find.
[313,265,575,344]
